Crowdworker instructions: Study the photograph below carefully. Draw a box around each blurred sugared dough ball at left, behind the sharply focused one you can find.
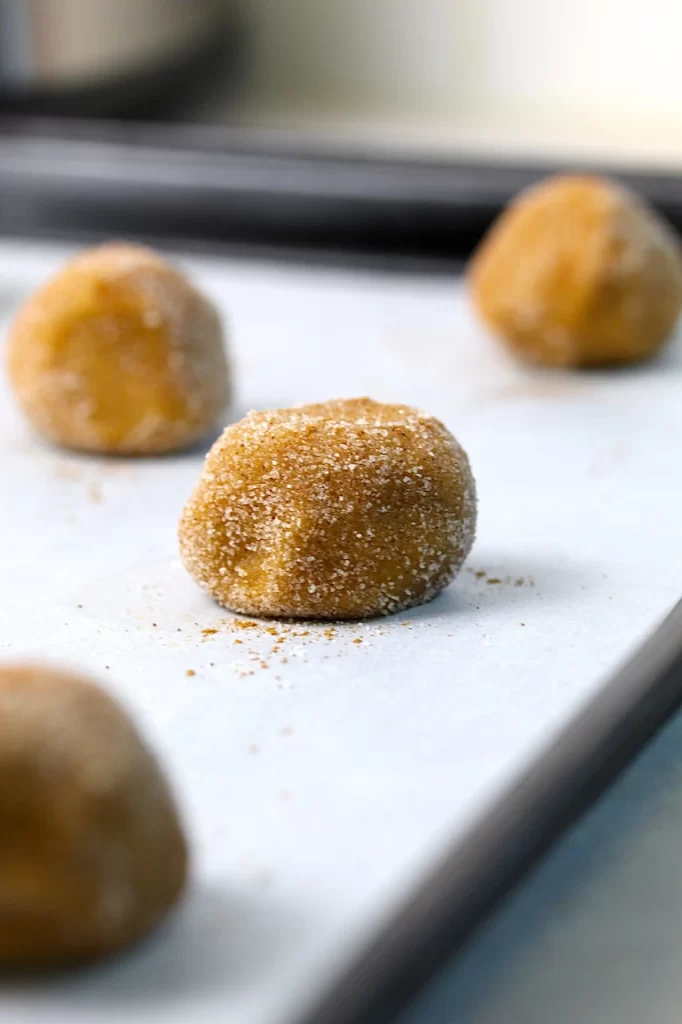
[8,244,229,455]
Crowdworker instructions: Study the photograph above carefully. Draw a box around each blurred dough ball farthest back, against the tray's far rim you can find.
[470,176,682,367]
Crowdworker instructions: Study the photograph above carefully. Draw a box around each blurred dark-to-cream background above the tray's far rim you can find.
[0,0,682,168]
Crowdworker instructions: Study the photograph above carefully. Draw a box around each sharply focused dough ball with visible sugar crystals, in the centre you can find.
[180,398,476,618]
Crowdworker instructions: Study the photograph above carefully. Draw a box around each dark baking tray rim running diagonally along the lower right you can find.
[290,601,682,1024]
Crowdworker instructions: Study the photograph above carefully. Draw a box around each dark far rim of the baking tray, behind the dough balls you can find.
[0,116,682,263]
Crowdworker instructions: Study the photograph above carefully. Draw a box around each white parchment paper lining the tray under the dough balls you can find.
[0,243,682,1024]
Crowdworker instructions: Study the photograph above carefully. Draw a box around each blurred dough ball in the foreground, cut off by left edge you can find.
[0,667,187,969]
